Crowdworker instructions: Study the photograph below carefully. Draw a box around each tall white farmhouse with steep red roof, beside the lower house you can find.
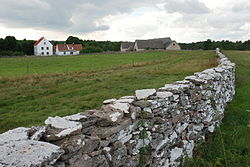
[34,37,53,56]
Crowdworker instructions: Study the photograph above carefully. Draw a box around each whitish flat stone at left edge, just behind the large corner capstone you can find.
[0,127,29,145]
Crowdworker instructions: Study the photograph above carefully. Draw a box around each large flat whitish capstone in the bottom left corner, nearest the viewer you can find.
[0,140,64,167]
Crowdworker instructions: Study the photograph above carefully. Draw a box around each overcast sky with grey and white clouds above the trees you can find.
[0,0,250,42]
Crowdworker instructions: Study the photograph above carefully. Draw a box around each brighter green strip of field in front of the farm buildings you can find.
[0,52,183,77]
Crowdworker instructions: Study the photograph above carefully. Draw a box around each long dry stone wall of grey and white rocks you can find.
[0,49,235,167]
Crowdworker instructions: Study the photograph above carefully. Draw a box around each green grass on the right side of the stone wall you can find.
[183,51,250,167]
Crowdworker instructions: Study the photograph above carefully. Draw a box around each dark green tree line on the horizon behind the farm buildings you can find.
[0,36,250,56]
